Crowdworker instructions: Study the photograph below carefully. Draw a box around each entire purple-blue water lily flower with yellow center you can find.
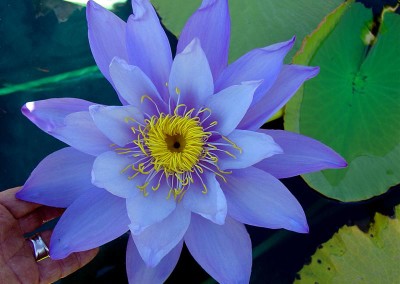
[17,0,346,283]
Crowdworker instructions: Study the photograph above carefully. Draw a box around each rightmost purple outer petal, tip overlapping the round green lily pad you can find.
[255,129,347,178]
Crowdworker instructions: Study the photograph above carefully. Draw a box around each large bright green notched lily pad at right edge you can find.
[285,3,400,201]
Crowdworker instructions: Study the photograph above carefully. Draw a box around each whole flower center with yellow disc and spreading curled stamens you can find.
[115,104,241,200]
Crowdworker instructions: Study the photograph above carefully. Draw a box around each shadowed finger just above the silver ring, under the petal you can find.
[19,206,65,234]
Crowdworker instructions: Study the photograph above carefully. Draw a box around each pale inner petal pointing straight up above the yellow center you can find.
[168,39,214,108]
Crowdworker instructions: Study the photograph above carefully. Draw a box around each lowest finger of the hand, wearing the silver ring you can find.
[38,231,99,283]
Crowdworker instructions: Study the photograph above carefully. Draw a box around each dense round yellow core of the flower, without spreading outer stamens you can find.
[143,113,209,174]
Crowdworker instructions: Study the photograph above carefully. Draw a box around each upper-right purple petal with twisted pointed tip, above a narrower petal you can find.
[215,38,295,104]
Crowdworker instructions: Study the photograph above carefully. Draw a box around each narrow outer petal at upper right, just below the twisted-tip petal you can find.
[239,65,319,130]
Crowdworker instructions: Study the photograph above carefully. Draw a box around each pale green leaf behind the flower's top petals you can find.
[151,0,343,61]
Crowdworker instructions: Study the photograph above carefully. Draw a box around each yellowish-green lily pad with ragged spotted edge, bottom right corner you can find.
[295,206,400,284]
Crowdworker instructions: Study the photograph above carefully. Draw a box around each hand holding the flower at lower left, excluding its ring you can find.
[0,187,98,284]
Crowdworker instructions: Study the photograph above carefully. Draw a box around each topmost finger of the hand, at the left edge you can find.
[0,186,42,219]
